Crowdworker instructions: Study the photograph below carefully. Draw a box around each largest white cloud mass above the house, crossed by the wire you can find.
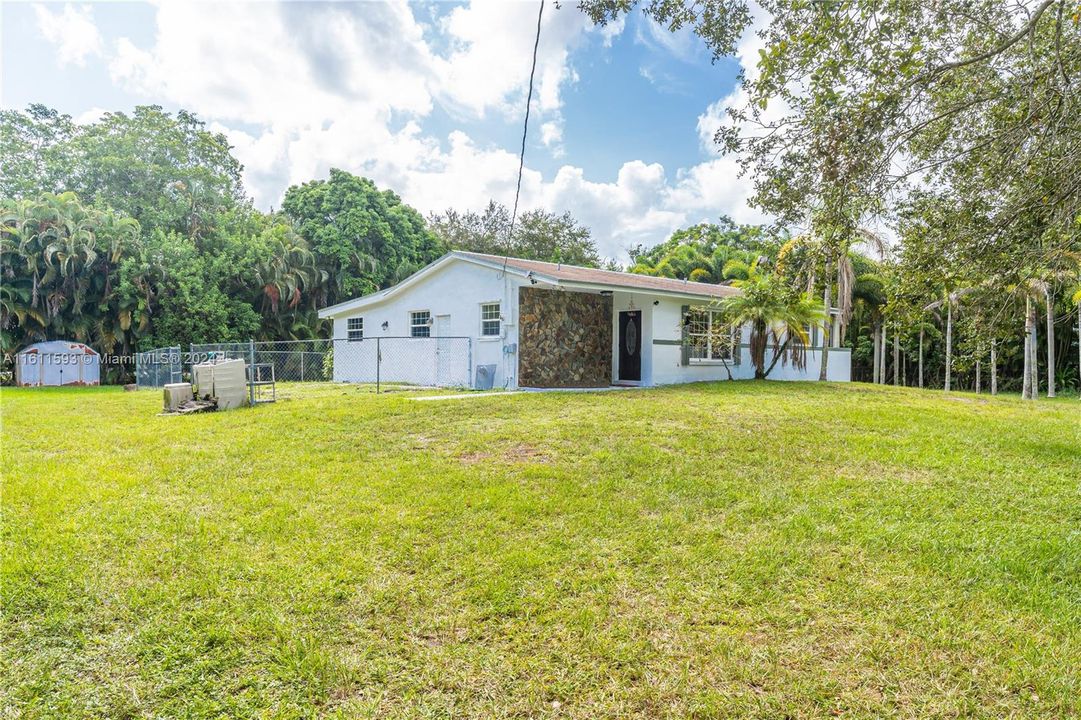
[90,2,778,259]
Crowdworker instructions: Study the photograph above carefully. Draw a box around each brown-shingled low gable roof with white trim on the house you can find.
[319,250,739,318]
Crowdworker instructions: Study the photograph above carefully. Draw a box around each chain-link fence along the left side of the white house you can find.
[182,337,472,391]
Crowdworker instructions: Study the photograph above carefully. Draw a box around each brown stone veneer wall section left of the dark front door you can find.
[518,288,612,387]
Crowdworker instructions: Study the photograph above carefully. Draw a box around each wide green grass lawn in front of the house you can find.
[0,383,1081,718]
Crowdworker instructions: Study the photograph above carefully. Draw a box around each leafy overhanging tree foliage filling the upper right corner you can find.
[579,0,1081,393]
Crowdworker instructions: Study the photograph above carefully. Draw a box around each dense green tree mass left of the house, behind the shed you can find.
[0,105,443,376]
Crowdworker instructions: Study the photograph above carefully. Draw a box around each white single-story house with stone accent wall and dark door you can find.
[319,251,851,388]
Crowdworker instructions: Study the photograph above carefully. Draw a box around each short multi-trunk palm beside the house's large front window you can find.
[721,263,826,379]
